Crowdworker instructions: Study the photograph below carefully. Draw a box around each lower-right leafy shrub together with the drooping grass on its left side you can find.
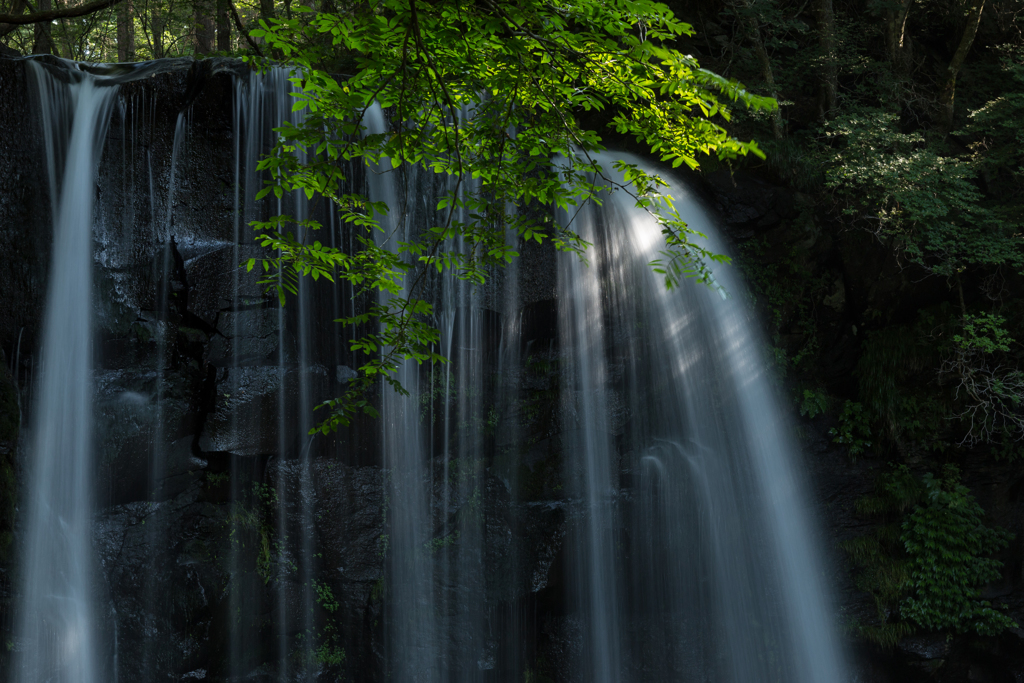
[843,465,1016,647]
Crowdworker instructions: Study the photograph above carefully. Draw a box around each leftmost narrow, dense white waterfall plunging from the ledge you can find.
[14,61,117,683]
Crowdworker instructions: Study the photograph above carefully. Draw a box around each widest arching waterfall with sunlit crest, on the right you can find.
[558,154,847,683]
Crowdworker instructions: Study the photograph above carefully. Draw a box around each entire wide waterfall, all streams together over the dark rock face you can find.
[8,57,848,683]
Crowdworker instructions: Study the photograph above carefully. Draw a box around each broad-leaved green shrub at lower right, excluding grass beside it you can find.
[900,465,1017,636]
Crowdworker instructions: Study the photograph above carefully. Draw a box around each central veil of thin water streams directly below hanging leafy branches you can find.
[365,102,507,682]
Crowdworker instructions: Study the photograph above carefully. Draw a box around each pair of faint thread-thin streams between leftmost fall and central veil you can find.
[229,67,319,681]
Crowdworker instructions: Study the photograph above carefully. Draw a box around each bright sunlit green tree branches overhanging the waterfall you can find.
[248,0,773,432]
